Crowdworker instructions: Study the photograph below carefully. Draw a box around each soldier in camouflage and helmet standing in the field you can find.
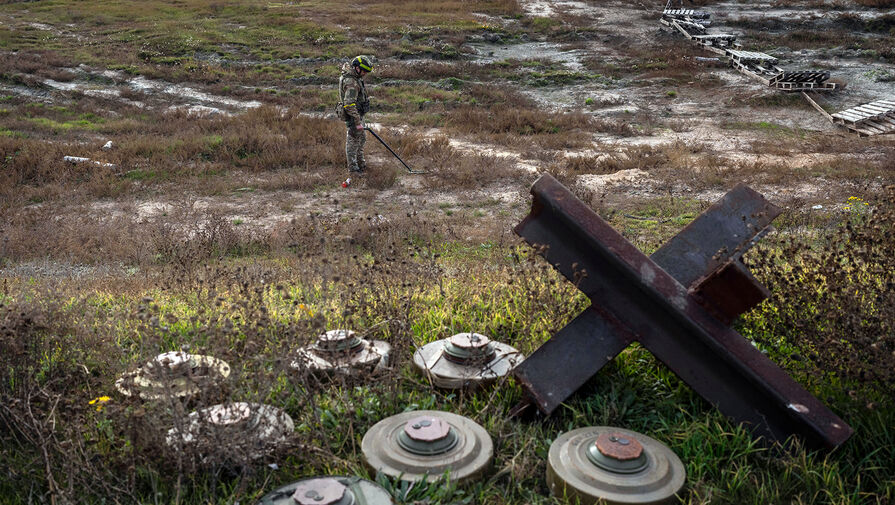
[339,56,373,172]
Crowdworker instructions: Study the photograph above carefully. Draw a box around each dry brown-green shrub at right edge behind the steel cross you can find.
[752,186,895,401]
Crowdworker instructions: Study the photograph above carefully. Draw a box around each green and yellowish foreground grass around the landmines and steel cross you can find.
[0,237,895,504]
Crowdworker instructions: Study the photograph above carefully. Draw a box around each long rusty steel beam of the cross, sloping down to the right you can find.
[516,175,852,447]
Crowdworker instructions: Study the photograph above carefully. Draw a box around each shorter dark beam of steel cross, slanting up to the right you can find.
[515,184,780,414]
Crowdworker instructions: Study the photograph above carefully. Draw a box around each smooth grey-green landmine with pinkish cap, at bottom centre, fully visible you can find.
[361,410,494,483]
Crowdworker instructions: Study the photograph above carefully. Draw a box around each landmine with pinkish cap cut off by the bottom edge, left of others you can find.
[252,476,393,505]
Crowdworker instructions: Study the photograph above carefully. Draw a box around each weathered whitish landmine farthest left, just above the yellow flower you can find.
[115,351,230,400]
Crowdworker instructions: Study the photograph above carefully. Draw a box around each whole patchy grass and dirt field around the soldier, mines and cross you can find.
[0,0,895,505]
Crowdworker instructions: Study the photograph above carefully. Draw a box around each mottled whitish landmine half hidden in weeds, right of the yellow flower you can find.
[166,402,295,460]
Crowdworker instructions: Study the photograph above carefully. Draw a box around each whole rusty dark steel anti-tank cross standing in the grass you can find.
[514,174,852,448]
